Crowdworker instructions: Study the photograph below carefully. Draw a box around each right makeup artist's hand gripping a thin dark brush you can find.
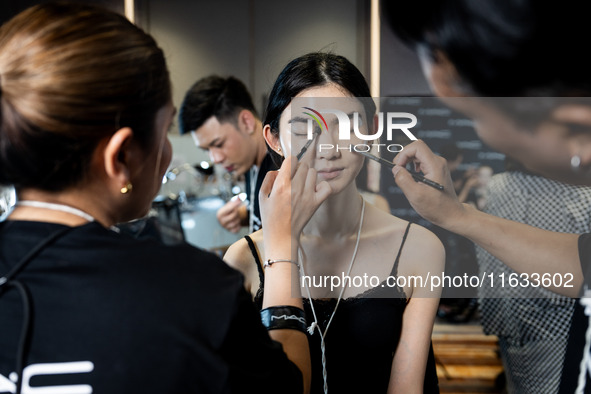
[392,140,464,228]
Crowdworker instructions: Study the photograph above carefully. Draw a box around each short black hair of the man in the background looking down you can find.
[179,75,258,134]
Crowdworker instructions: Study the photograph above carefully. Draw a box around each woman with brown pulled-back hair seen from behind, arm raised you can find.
[0,3,322,394]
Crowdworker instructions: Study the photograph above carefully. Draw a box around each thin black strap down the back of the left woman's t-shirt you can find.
[0,227,73,394]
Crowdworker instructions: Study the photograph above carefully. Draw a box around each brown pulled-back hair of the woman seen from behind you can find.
[0,3,171,191]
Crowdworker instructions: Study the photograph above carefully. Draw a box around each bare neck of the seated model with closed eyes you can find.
[303,184,362,239]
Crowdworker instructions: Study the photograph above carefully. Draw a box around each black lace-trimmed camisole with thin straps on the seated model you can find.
[245,223,439,394]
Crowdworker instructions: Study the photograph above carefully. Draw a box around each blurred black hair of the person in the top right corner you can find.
[382,0,591,97]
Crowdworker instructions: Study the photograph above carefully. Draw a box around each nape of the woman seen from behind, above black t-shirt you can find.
[8,189,116,227]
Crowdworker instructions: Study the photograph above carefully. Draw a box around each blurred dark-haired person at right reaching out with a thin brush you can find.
[382,0,591,393]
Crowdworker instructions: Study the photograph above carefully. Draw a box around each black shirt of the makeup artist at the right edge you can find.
[560,234,591,394]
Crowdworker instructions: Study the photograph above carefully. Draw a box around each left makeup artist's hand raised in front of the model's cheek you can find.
[259,156,331,243]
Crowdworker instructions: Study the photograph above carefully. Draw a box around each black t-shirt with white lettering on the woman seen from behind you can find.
[0,221,301,394]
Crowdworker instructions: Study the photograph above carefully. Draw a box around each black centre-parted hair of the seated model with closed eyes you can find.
[263,52,376,165]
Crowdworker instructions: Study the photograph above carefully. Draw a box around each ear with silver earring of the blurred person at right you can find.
[550,104,591,167]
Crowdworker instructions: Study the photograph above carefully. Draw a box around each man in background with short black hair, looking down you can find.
[179,75,277,233]
